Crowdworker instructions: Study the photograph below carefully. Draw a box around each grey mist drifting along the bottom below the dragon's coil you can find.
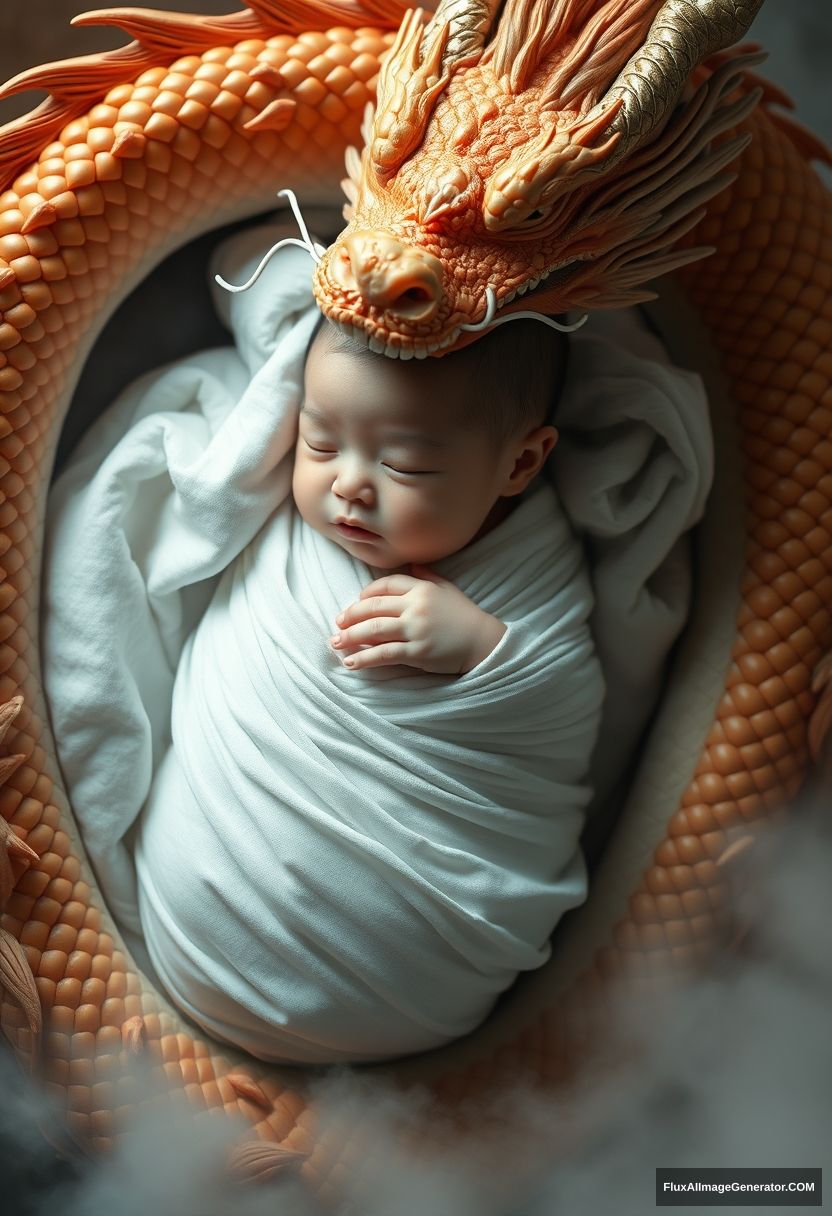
[0,807,832,1216]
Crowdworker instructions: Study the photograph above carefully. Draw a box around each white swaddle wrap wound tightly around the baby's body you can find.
[136,485,603,1063]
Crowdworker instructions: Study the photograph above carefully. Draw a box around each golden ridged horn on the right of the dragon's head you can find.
[591,0,763,164]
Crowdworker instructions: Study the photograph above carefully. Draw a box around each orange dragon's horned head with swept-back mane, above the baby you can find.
[315,0,761,359]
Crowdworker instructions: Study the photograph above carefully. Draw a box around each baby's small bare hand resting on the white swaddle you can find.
[330,565,506,675]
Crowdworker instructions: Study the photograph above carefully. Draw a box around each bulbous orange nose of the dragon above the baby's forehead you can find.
[330,230,442,322]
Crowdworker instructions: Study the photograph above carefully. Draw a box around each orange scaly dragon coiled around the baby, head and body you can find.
[0,0,832,1197]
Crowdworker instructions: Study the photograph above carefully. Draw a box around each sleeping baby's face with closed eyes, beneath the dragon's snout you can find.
[292,326,515,569]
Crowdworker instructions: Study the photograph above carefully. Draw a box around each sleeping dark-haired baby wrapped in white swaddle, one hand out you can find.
[128,321,603,1063]
